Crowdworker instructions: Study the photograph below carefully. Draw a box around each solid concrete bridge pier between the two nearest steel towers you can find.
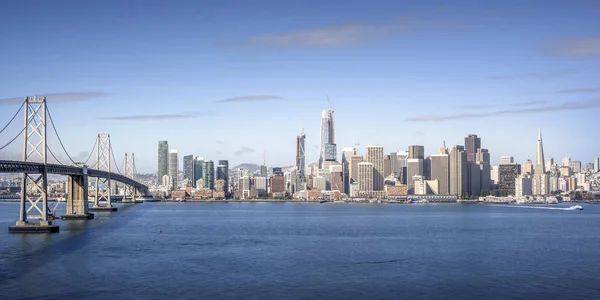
[61,173,94,220]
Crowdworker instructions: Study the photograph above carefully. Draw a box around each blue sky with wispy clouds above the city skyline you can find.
[0,0,600,172]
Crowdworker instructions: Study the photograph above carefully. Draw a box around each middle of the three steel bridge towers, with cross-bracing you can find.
[90,133,117,211]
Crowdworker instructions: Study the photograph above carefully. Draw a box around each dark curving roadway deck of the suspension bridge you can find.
[0,160,148,191]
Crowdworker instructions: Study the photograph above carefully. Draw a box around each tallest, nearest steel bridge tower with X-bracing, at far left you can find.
[8,96,59,233]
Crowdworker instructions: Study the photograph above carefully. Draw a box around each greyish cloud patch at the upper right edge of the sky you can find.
[540,36,600,57]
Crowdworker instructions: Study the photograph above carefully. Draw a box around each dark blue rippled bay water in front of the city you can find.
[0,203,600,299]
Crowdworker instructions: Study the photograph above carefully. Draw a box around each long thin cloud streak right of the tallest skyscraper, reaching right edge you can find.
[406,99,600,122]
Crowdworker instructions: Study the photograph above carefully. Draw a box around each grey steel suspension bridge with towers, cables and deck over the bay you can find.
[0,96,148,233]
